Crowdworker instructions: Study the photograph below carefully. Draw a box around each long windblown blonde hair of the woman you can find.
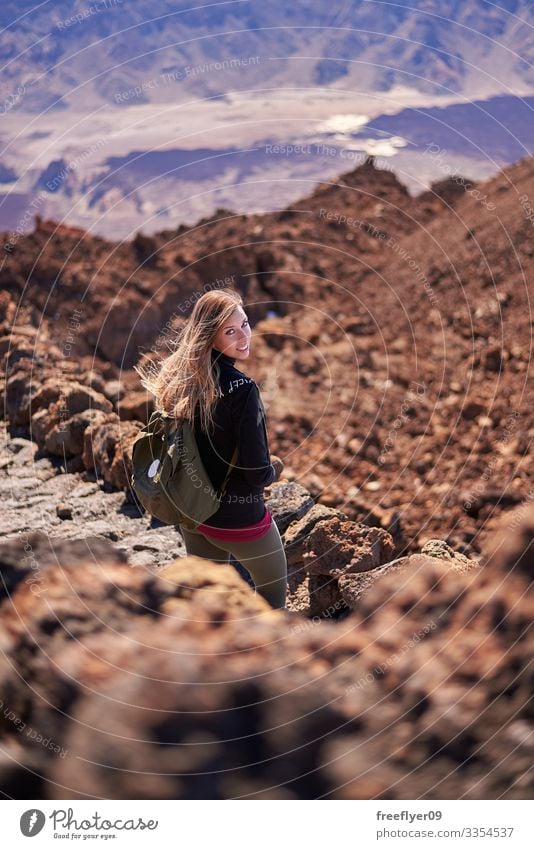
[134,287,243,433]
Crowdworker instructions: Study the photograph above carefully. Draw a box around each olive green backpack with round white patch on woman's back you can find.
[130,410,237,530]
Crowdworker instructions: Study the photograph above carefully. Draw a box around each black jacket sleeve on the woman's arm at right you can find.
[233,383,276,487]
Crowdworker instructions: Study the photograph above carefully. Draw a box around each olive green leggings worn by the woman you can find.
[178,522,287,608]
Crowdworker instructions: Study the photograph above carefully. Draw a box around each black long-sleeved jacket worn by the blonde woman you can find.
[195,348,276,528]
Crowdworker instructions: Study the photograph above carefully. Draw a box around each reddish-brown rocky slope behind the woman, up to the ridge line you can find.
[0,154,534,556]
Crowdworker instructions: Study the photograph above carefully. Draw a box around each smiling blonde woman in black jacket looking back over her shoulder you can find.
[136,288,287,608]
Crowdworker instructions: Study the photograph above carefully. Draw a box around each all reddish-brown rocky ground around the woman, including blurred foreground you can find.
[0,151,534,799]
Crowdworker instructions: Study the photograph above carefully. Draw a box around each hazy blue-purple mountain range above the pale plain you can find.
[0,0,534,112]
